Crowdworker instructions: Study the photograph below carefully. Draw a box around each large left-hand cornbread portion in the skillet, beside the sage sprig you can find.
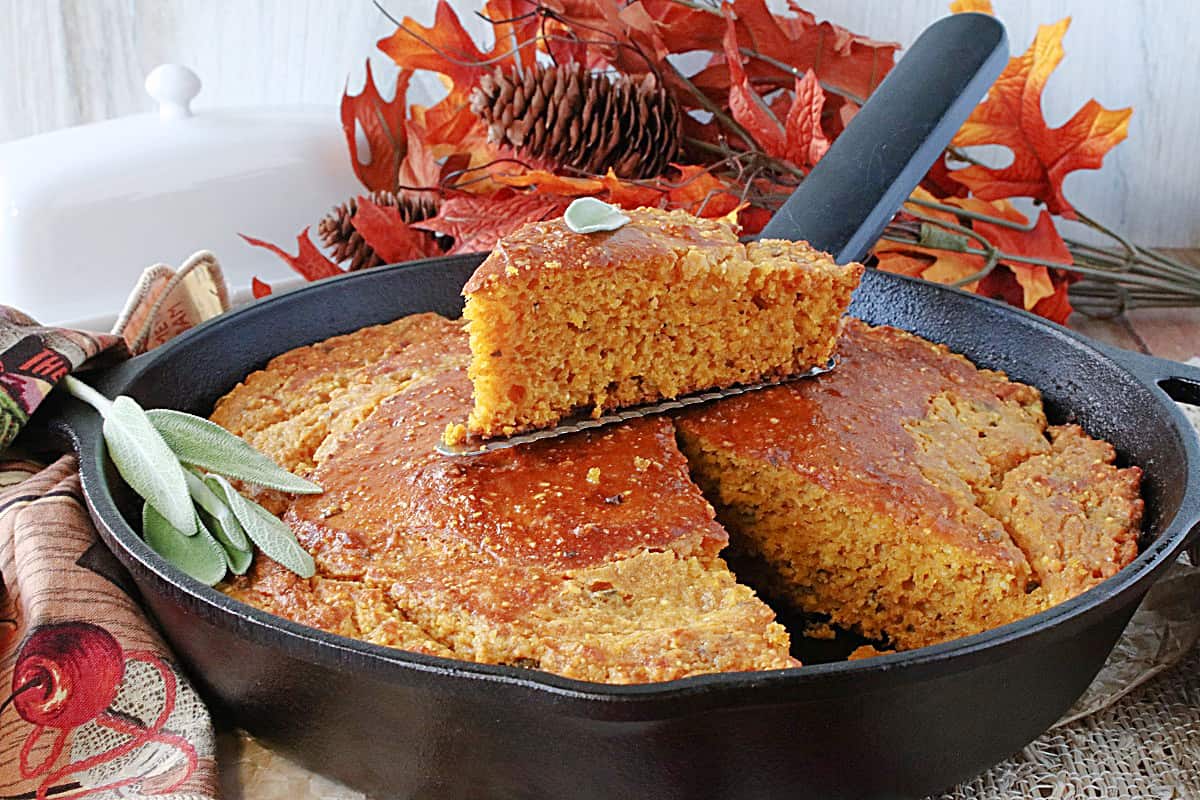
[212,314,796,682]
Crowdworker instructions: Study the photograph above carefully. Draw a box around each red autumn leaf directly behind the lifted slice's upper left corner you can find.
[413,190,569,253]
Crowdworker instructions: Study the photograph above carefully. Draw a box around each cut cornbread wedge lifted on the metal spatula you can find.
[458,209,863,441]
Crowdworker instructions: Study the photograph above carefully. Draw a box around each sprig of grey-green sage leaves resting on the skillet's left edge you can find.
[62,375,322,587]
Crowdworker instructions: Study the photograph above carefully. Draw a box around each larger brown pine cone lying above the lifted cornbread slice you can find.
[470,64,682,178]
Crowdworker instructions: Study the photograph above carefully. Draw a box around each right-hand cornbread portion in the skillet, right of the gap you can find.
[677,320,1142,649]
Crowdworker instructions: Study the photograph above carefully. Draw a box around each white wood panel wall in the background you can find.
[0,0,1200,247]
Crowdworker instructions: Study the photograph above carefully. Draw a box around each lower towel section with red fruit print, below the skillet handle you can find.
[0,456,216,800]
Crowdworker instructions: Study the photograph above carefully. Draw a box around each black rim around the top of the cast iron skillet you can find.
[68,253,1200,714]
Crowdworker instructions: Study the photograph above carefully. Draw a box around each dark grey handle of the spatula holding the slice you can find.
[760,13,1008,264]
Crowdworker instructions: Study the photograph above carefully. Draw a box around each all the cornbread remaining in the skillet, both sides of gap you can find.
[214,314,1141,682]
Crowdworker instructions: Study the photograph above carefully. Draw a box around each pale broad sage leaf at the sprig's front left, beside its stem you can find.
[103,395,197,536]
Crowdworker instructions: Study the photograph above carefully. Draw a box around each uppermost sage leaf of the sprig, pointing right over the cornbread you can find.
[146,408,320,494]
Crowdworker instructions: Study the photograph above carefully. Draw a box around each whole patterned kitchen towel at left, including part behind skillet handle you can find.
[0,253,228,800]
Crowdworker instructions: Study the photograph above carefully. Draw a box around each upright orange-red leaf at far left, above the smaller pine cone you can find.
[342,61,412,192]
